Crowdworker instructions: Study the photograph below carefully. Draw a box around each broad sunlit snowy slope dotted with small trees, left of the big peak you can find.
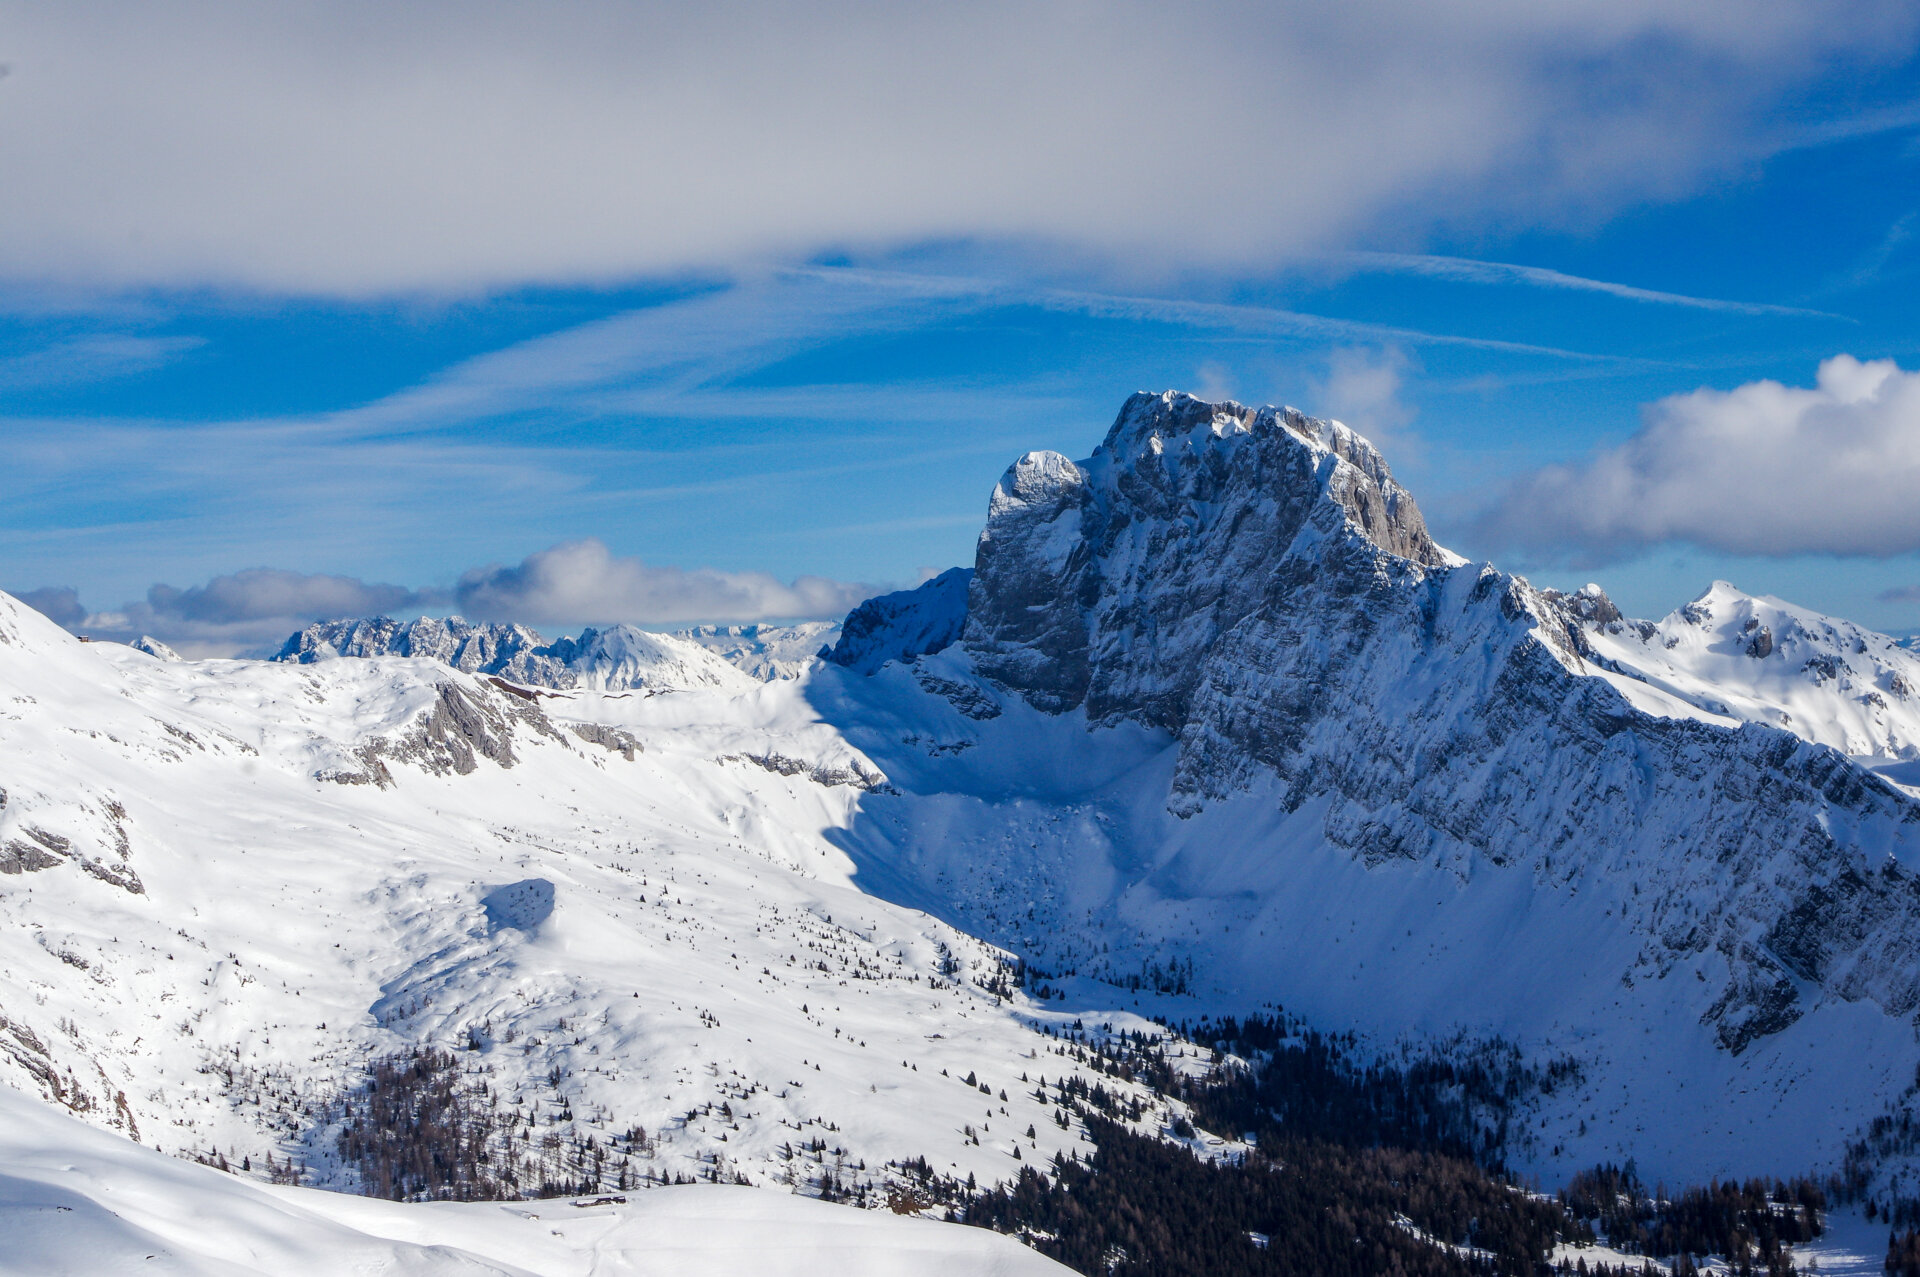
[0,597,1190,1194]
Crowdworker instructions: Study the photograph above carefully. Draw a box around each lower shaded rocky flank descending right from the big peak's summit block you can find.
[1173,556,1920,1052]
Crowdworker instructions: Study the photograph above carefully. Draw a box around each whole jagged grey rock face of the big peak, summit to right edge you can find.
[966,385,1920,1052]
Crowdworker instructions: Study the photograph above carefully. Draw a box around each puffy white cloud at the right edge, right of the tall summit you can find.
[1476,355,1920,563]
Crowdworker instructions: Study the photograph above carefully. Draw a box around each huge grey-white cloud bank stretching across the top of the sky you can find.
[0,0,1916,294]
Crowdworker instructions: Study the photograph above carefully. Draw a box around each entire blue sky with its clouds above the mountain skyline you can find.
[0,4,1920,651]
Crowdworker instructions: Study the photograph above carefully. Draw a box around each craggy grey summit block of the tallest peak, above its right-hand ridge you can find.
[966,392,1446,730]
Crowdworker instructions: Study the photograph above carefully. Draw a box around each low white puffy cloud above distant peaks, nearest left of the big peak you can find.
[453,540,874,624]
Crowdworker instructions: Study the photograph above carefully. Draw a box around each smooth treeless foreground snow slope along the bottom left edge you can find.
[0,1089,1066,1277]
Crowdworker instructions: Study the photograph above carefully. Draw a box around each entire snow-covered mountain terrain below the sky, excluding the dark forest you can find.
[11,394,1920,1273]
